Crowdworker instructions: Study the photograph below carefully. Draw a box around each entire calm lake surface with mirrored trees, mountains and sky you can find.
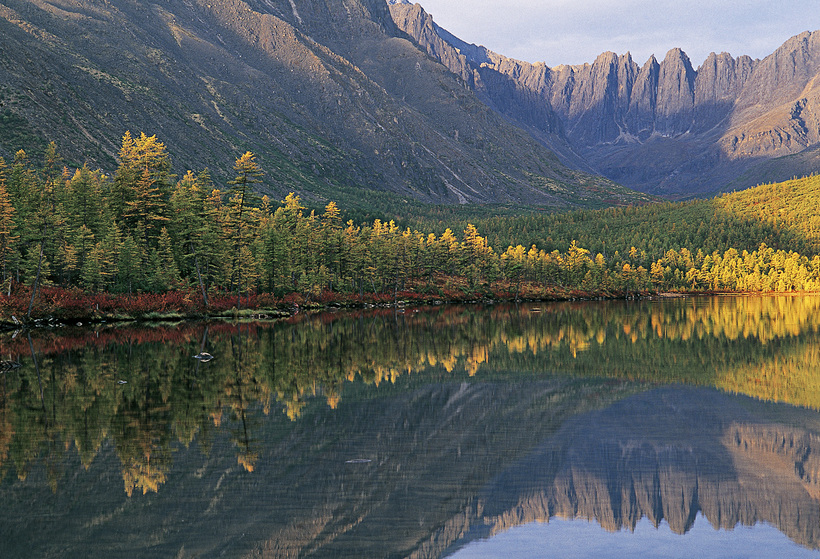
[0,296,820,558]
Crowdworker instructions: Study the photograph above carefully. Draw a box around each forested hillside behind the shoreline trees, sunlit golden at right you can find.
[432,176,820,260]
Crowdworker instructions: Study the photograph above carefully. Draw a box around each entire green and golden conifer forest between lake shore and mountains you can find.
[0,133,820,322]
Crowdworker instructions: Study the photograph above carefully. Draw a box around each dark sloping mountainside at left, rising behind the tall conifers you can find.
[0,0,636,207]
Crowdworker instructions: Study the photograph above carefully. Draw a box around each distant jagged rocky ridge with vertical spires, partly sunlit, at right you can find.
[391,3,820,197]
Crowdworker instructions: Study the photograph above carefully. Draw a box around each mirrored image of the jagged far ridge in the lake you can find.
[454,387,820,548]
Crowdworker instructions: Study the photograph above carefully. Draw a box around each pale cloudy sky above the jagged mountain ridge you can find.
[411,0,820,68]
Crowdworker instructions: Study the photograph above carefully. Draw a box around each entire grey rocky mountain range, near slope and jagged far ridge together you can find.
[0,0,820,209]
